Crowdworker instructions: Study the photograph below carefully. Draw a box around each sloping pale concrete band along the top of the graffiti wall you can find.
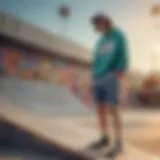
[0,12,92,63]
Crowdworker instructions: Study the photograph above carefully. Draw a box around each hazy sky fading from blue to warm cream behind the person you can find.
[0,0,160,71]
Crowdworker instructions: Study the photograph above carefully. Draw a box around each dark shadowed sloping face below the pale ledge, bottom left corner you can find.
[0,120,90,160]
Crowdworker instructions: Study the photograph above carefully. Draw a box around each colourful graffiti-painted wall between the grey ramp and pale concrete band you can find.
[0,45,91,104]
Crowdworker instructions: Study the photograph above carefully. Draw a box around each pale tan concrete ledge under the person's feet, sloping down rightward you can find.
[0,103,159,160]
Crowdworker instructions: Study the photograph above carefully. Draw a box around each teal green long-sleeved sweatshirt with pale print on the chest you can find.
[93,28,129,79]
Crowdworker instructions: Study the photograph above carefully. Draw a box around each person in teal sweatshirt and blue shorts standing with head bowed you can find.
[91,14,129,157]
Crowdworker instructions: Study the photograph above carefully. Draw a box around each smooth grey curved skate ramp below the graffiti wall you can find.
[0,78,91,116]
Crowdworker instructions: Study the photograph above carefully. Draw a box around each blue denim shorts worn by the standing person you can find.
[93,74,119,106]
